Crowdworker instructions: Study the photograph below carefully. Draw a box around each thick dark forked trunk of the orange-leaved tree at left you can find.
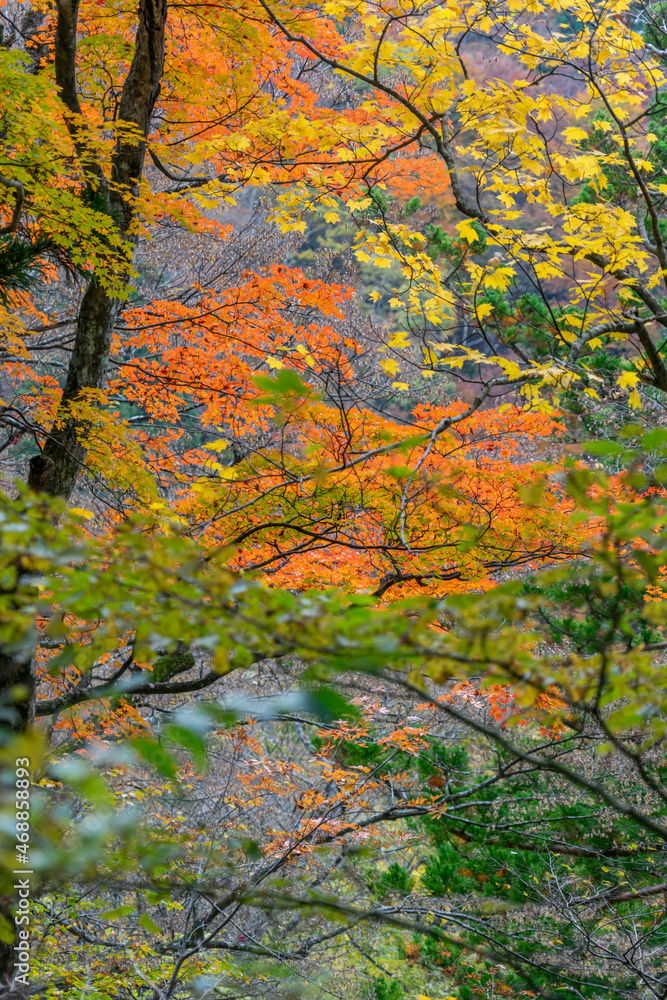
[0,0,167,997]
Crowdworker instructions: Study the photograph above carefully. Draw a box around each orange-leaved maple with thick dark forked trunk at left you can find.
[3,5,604,740]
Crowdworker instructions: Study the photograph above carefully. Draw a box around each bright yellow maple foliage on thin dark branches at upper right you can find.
[252,3,664,418]
